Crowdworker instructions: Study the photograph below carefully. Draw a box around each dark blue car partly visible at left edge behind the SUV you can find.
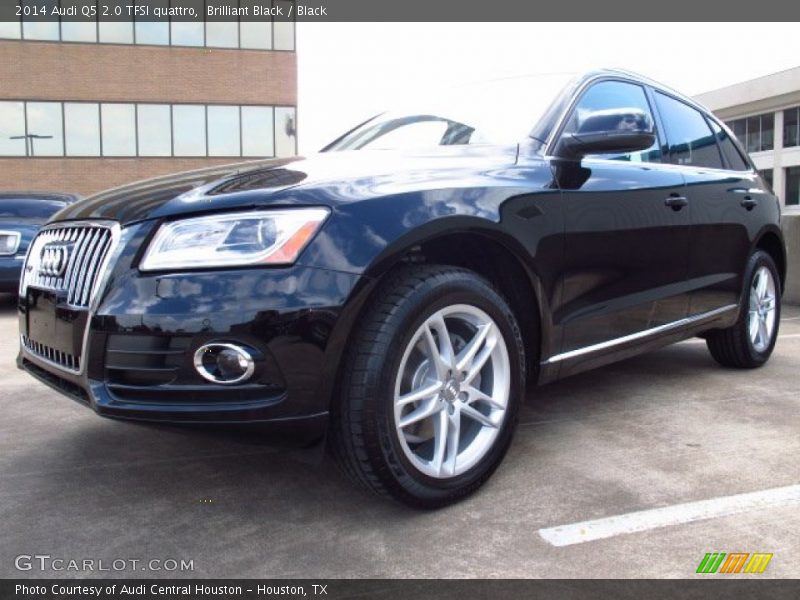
[0,192,78,293]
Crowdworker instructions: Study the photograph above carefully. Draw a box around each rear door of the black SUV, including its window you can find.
[655,91,774,315]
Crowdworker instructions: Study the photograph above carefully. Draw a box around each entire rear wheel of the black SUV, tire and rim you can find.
[706,250,781,369]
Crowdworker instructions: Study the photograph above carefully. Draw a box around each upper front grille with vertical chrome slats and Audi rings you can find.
[22,222,113,308]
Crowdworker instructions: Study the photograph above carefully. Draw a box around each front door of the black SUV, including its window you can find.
[554,80,691,354]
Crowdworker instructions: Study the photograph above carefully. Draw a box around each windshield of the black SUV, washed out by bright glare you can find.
[323,73,574,152]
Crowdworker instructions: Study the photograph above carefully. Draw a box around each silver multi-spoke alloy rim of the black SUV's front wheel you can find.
[394,304,511,479]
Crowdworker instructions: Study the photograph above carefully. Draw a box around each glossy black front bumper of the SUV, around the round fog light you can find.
[17,250,360,437]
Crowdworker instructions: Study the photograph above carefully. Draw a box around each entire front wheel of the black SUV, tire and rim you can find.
[329,265,525,509]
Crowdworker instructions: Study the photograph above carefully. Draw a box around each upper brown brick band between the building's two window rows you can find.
[0,41,297,106]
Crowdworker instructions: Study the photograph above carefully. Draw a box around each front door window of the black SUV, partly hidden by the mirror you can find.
[564,81,661,162]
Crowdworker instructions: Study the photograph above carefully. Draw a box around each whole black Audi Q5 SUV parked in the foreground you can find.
[19,71,786,507]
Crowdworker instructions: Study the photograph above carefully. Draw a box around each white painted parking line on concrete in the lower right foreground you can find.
[539,485,800,546]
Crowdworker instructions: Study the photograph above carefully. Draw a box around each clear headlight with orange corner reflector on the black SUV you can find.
[139,208,330,271]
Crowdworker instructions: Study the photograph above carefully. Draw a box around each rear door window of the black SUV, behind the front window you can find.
[656,92,723,169]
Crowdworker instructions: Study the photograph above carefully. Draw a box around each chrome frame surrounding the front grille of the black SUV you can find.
[19,219,125,376]
